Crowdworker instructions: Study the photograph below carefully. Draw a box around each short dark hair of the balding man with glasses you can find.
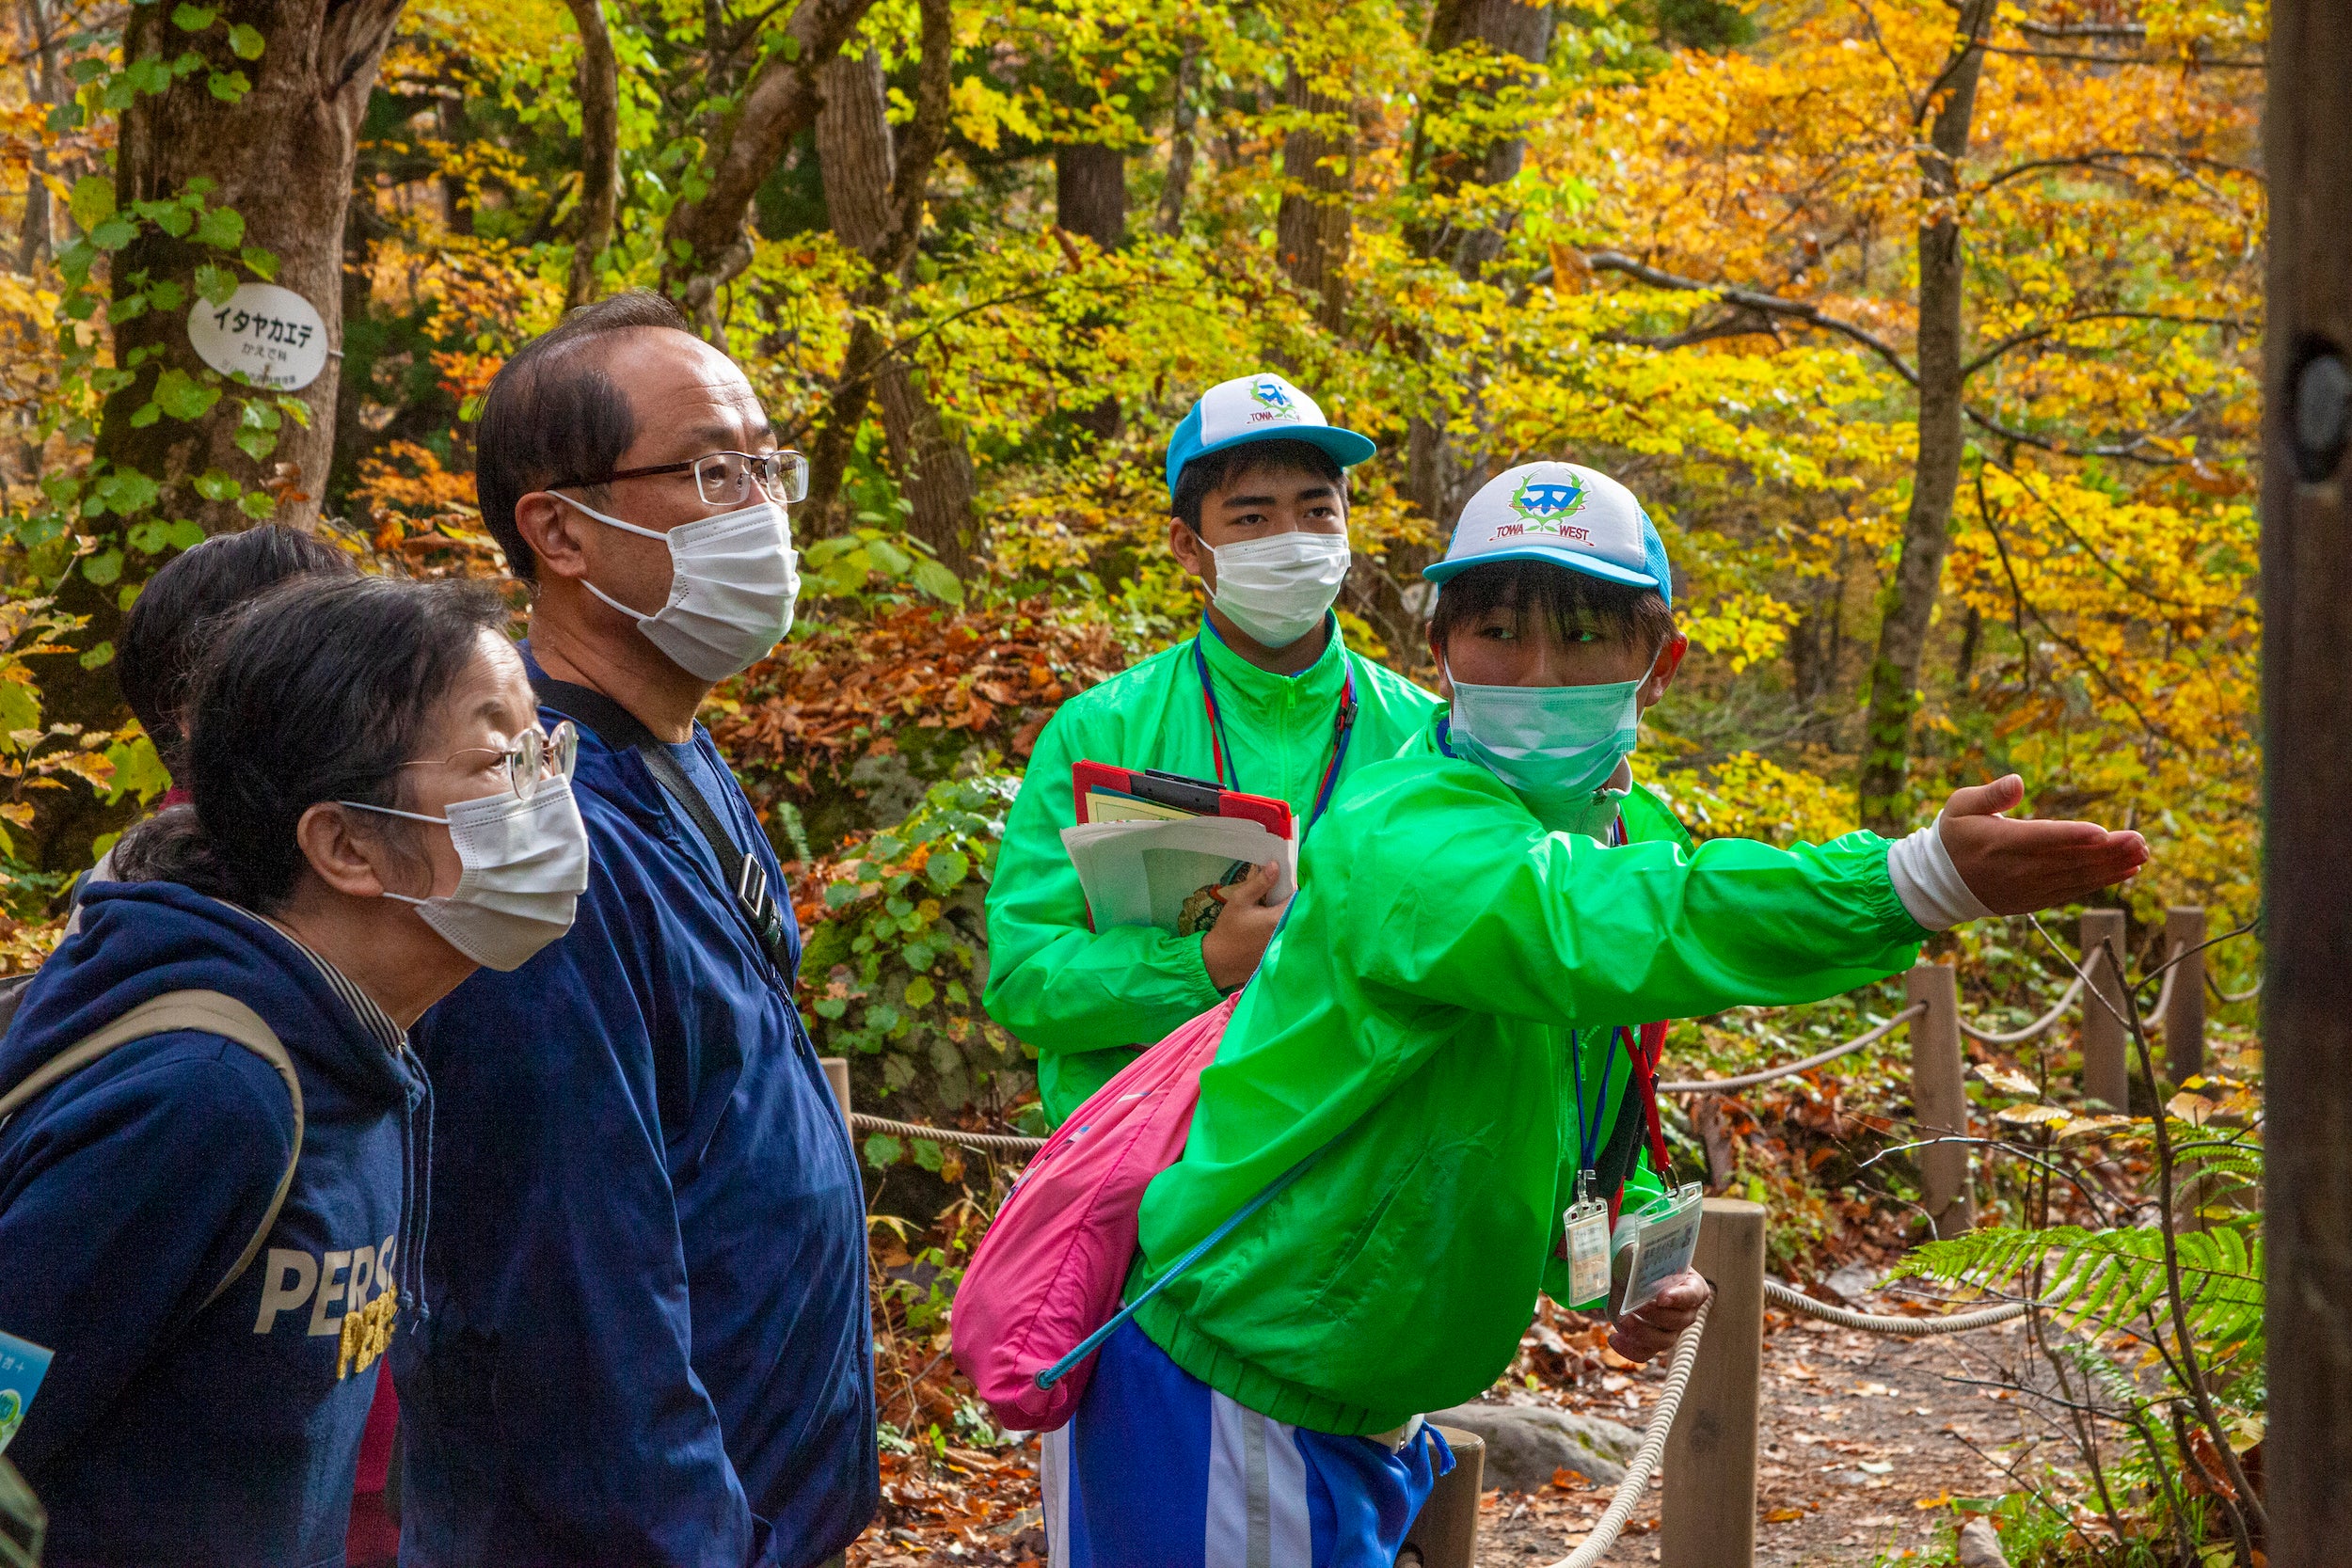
[473,289,694,583]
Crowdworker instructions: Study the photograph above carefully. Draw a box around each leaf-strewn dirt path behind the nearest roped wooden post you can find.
[1480,1314,2021,1568]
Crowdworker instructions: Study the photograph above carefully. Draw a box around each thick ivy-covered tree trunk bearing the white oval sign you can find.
[19,0,400,867]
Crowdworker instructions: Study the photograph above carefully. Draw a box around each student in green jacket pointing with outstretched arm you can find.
[1044,463,2148,1568]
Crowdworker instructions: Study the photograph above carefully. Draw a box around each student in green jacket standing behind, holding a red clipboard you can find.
[986,373,1438,1126]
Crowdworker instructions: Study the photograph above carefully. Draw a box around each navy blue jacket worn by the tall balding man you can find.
[393,686,880,1568]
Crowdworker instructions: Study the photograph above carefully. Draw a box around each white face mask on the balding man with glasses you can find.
[550,491,800,682]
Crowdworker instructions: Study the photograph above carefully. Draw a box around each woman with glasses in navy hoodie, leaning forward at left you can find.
[0,578,588,1568]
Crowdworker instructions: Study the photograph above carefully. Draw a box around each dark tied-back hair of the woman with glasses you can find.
[116,576,506,914]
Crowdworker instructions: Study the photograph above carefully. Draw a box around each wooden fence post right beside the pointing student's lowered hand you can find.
[1659,1203,1769,1568]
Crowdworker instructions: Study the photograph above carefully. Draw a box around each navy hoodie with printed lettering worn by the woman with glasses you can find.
[0,881,426,1568]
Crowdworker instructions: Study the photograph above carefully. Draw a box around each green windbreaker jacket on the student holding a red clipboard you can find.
[983,623,1438,1126]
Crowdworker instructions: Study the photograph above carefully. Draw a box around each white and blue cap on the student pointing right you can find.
[1421,463,1675,604]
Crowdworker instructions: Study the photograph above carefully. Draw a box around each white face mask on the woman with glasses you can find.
[339,778,588,971]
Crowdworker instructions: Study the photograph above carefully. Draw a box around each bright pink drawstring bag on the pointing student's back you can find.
[953,992,1287,1432]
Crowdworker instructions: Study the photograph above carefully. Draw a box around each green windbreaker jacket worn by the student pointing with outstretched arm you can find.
[1129,724,1927,1434]
